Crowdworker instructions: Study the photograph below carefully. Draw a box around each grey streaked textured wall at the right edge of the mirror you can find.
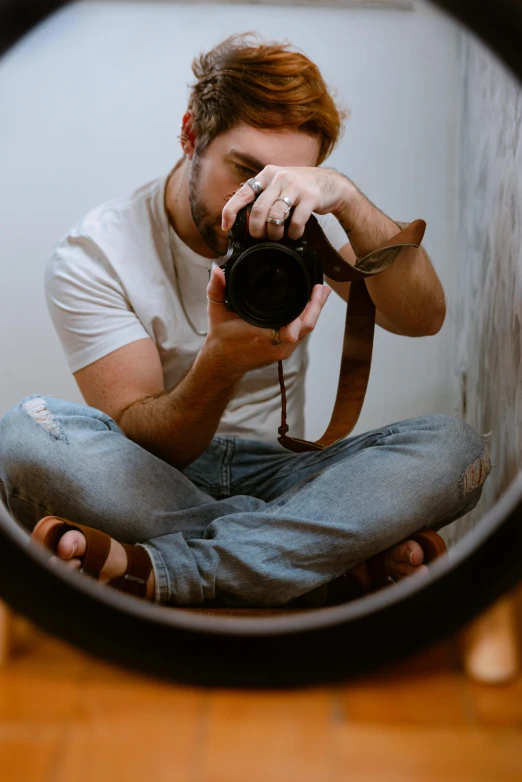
[444,35,522,539]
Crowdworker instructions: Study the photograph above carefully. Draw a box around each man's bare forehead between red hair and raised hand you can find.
[210,124,320,170]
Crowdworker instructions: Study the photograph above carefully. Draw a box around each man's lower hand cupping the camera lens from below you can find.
[203,265,332,379]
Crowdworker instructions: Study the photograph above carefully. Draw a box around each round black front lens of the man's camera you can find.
[227,247,312,328]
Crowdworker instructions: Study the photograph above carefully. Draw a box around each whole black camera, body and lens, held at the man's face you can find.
[215,204,323,329]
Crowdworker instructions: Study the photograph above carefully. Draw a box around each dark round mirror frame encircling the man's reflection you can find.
[0,0,522,688]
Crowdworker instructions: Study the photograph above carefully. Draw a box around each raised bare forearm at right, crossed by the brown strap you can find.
[336,177,446,336]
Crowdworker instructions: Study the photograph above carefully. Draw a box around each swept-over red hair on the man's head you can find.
[188,33,349,165]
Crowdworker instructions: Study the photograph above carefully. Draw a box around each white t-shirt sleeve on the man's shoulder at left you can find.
[44,235,150,372]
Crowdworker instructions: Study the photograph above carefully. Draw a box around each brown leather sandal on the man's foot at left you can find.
[31,516,152,599]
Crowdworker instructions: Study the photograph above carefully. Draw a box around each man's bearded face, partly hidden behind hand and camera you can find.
[185,124,319,255]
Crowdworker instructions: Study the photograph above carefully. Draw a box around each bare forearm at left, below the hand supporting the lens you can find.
[119,344,241,470]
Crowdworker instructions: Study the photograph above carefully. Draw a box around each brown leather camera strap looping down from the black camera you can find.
[278,215,426,453]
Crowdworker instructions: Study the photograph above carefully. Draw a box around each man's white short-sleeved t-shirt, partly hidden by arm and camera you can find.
[45,175,348,442]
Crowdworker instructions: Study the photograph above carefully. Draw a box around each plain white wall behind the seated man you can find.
[0,2,457,436]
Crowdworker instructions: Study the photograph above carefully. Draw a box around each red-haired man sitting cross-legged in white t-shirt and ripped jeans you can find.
[0,35,490,605]
